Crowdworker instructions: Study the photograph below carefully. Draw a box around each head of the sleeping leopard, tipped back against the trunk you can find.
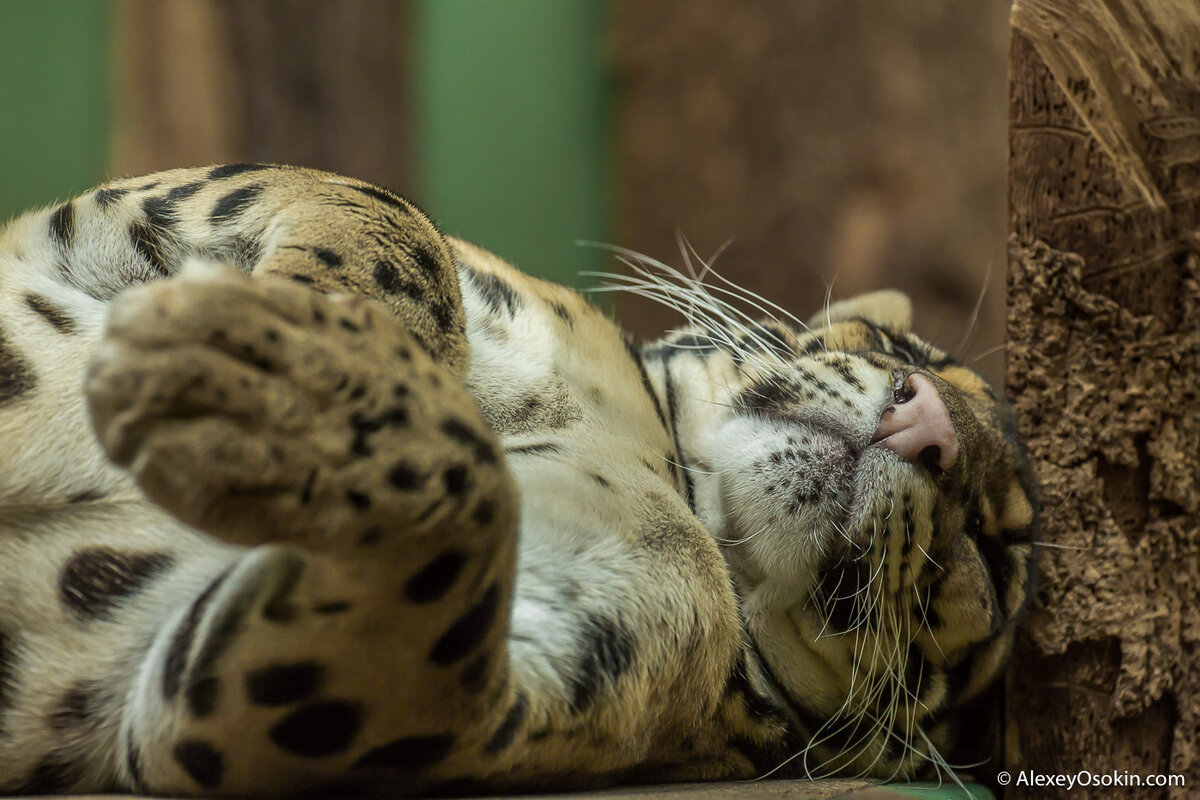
[655,284,1037,777]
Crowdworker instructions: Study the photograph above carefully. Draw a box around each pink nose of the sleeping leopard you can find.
[871,374,959,469]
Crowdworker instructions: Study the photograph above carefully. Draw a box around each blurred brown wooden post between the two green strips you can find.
[113,0,412,190]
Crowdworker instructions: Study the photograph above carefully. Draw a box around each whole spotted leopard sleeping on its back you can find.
[0,164,1037,796]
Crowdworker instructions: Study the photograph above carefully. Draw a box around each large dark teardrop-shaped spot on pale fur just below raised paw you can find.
[59,547,173,619]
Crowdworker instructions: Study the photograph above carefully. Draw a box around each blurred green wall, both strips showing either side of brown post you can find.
[0,0,612,291]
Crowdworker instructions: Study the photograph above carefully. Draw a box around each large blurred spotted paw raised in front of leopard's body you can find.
[86,265,512,547]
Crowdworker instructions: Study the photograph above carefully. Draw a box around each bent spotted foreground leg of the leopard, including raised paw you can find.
[86,267,516,794]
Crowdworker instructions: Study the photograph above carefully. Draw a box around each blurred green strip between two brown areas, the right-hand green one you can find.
[414,0,612,284]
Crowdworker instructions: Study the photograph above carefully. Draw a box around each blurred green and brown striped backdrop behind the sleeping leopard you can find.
[0,0,1009,379]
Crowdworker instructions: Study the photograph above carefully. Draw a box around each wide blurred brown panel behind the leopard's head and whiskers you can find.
[613,0,1009,383]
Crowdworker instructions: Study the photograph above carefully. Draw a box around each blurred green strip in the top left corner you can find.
[0,0,110,221]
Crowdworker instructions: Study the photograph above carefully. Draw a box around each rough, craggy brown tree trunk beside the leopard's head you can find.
[1006,0,1200,800]
